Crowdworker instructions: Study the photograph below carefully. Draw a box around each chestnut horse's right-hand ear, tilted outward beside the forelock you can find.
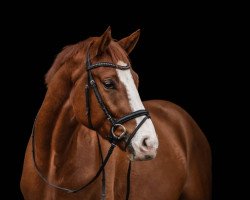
[118,29,141,54]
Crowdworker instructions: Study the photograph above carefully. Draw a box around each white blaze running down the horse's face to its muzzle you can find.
[116,61,158,159]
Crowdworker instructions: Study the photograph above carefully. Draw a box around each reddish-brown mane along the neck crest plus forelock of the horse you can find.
[45,37,129,86]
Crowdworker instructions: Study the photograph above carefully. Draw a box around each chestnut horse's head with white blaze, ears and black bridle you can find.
[47,28,158,160]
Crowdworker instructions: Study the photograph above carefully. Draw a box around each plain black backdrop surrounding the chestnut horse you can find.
[2,2,246,199]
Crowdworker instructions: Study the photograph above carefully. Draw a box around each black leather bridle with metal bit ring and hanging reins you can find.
[31,43,150,200]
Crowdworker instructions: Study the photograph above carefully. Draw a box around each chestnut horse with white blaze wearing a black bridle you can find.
[20,27,211,200]
